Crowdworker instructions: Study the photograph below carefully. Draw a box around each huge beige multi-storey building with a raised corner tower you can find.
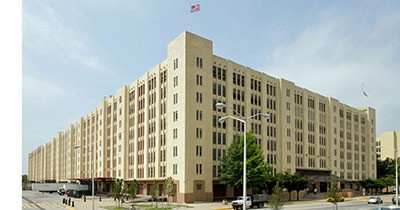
[28,32,376,202]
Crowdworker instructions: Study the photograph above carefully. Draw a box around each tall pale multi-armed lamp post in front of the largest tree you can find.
[215,103,270,210]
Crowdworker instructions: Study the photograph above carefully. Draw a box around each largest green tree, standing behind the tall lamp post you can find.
[219,133,272,189]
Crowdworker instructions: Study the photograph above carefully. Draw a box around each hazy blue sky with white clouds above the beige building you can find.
[22,0,400,174]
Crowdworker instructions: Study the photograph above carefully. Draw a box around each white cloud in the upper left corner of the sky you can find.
[23,2,105,71]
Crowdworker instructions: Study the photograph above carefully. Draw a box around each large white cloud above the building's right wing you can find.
[264,6,400,135]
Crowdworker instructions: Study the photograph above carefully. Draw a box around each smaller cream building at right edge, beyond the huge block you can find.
[377,131,400,160]
